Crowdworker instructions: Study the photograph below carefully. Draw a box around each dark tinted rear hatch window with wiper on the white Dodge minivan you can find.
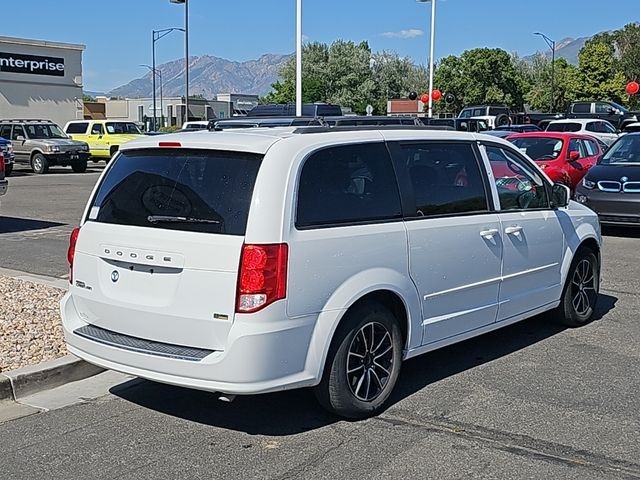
[88,149,262,235]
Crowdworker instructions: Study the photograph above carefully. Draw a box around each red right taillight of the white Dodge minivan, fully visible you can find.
[236,243,289,313]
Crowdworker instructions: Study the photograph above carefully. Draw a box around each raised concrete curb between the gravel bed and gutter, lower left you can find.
[0,355,104,400]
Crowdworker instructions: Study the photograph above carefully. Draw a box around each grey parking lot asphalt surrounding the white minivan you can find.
[0,163,640,479]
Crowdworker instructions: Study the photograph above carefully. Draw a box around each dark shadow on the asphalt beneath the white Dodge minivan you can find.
[110,295,617,436]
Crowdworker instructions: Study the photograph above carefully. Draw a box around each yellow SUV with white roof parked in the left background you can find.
[64,120,144,161]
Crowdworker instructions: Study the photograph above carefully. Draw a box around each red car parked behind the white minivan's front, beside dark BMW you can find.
[507,132,604,191]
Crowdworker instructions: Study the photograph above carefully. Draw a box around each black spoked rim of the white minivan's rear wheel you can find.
[346,322,394,402]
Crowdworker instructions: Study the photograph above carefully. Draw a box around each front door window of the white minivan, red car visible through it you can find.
[487,146,549,210]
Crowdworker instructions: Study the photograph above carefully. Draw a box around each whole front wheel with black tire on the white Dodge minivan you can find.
[551,249,600,327]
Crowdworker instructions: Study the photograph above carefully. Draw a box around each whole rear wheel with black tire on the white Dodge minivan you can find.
[315,302,403,418]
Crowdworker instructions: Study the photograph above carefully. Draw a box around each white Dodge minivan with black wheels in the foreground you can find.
[61,127,601,418]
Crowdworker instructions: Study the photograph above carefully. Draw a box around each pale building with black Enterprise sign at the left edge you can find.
[0,37,85,125]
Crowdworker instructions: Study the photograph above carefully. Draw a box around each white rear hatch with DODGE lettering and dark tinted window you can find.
[72,148,262,350]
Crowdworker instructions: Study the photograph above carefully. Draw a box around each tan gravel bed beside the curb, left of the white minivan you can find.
[0,276,67,372]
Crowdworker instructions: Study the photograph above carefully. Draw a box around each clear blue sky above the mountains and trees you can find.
[5,0,640,91]
